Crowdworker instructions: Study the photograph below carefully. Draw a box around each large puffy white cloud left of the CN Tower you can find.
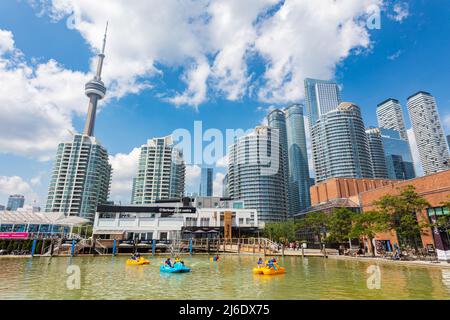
[0,30,87,160]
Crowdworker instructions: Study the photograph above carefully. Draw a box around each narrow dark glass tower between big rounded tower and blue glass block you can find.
[366,128,388,179]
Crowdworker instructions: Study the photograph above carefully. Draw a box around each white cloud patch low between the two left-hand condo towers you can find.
[109,148,141,203]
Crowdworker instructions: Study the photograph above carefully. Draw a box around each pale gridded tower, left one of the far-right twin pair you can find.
[377,98,408,141]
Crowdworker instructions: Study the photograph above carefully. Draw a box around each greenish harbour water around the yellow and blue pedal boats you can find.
[0,256,450,300]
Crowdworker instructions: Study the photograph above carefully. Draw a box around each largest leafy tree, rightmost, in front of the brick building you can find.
[374,185,430,250]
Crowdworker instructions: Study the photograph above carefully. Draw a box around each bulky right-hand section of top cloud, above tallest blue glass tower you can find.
[255,0,382,103]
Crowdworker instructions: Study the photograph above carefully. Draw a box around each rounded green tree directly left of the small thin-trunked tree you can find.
[327,207,355,243]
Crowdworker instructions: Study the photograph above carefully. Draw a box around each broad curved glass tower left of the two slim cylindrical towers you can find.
[228,126,288,222]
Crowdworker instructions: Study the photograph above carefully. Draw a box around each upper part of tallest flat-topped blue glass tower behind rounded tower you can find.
[305,79,342,128]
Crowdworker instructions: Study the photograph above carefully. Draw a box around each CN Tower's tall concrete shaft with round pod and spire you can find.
[83,23,108,137]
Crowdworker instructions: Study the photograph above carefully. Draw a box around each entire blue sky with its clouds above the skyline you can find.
[0,0,450,205]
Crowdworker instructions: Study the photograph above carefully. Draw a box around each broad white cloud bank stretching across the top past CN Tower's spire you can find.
[30,0,383,107]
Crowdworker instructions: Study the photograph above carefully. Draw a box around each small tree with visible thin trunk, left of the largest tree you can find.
[349,211,389,256]
